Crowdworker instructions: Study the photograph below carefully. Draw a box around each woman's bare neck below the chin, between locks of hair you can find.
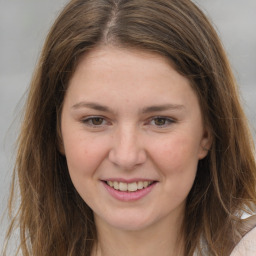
[92,214,184,256]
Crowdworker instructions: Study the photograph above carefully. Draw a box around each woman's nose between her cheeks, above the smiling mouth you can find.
[109,124,147,170]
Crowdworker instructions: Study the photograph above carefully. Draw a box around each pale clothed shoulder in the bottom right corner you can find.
[230,227,256,256]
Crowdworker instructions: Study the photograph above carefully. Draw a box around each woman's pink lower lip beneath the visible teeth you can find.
[102,182,157,202]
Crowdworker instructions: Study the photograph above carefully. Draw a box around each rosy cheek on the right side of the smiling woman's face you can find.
[151,136,198,210]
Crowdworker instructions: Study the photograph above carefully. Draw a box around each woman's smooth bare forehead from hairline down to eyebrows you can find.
[64,46,200,114]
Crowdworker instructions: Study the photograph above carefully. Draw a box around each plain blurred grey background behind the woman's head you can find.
[0,0,256,248]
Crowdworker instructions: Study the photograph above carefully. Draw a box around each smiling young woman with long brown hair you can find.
[3,0,256,256]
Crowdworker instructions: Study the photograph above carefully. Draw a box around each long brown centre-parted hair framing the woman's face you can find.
[4,0,256,256]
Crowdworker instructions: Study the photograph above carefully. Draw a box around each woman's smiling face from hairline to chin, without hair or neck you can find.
[61,46,210,230]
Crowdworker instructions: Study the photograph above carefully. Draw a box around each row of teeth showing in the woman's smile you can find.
[107,181,153,192]
